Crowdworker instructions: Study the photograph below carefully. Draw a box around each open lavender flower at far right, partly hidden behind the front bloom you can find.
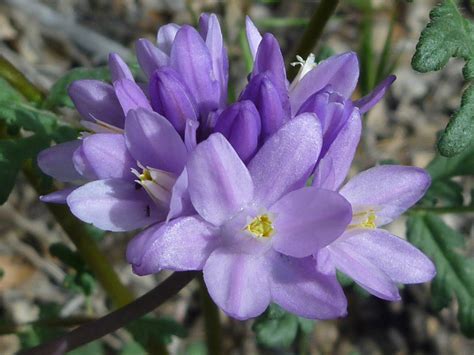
[314,166,436,301]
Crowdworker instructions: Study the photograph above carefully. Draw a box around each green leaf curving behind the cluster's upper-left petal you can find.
[43,67,110,110]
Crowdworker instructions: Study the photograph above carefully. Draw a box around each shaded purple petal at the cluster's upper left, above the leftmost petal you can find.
[68,80,125,128]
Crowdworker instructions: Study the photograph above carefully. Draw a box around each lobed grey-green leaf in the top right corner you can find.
[412,0,474,157]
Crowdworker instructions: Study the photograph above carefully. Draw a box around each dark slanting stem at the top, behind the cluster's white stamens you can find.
[286,0,339,81]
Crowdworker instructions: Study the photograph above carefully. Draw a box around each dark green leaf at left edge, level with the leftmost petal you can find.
[0,135,49,204]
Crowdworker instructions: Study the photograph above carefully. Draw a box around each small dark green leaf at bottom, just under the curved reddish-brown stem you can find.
[127,317,188,348]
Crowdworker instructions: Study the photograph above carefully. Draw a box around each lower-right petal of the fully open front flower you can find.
[270,253,347,319]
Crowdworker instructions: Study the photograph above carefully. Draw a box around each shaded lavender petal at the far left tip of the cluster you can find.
[38,139,82,182]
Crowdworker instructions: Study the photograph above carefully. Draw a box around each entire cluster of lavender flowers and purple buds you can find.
[38,14,435,319]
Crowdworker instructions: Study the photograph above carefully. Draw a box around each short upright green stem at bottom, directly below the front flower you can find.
[199,276,222,355]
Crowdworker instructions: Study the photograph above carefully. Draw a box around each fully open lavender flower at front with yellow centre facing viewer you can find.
[127,114,351,319]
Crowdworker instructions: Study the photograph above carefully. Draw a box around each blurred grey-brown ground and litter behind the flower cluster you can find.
[0,0,474,355]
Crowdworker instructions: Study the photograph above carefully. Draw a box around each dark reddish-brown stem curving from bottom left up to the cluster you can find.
[20,271,198,355]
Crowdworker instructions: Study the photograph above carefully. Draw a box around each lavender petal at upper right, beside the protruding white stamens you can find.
[290,52,359,112]
